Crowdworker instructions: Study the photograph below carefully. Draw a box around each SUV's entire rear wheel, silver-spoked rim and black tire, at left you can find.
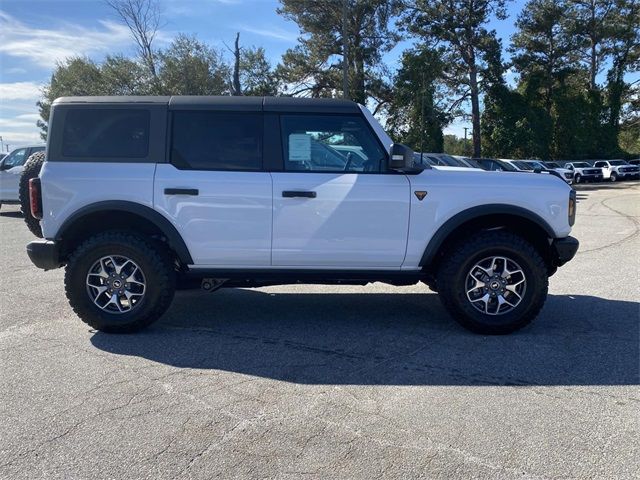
[65,232,175,333]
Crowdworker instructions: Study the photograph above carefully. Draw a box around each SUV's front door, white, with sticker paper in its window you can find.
[272,114,410,269]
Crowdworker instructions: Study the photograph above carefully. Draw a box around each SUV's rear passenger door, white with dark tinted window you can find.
[154,101,272,267]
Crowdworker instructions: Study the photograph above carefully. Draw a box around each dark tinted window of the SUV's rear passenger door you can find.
[171,111,262,170]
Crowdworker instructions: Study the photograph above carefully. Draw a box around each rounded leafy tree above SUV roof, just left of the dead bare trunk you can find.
[158,34,230,95]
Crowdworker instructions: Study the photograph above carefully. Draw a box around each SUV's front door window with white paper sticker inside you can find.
[281,115,386,173]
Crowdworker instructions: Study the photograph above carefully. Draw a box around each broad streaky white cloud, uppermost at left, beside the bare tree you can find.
[0,11,131,68]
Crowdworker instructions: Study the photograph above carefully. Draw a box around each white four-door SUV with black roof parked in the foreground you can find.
[27,97,578,334]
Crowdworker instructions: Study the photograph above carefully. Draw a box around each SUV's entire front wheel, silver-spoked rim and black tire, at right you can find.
[437,231,549,335]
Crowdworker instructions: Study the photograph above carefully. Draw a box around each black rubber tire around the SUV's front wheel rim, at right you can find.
[437,231,549,335]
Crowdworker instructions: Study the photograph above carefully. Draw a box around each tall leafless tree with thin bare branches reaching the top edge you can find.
[105,0,160,86]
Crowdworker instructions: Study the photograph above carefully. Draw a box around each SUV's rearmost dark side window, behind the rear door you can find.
[62,108,149,158]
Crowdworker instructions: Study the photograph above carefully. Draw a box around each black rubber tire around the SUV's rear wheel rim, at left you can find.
[64,231,176,333]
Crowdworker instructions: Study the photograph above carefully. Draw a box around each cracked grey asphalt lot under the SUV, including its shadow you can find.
[0,183,640,479]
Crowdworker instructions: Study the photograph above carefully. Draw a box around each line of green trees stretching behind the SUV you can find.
[38,0,640,159]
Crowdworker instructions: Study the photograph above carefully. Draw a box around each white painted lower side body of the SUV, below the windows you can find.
[40,158,571,270]
